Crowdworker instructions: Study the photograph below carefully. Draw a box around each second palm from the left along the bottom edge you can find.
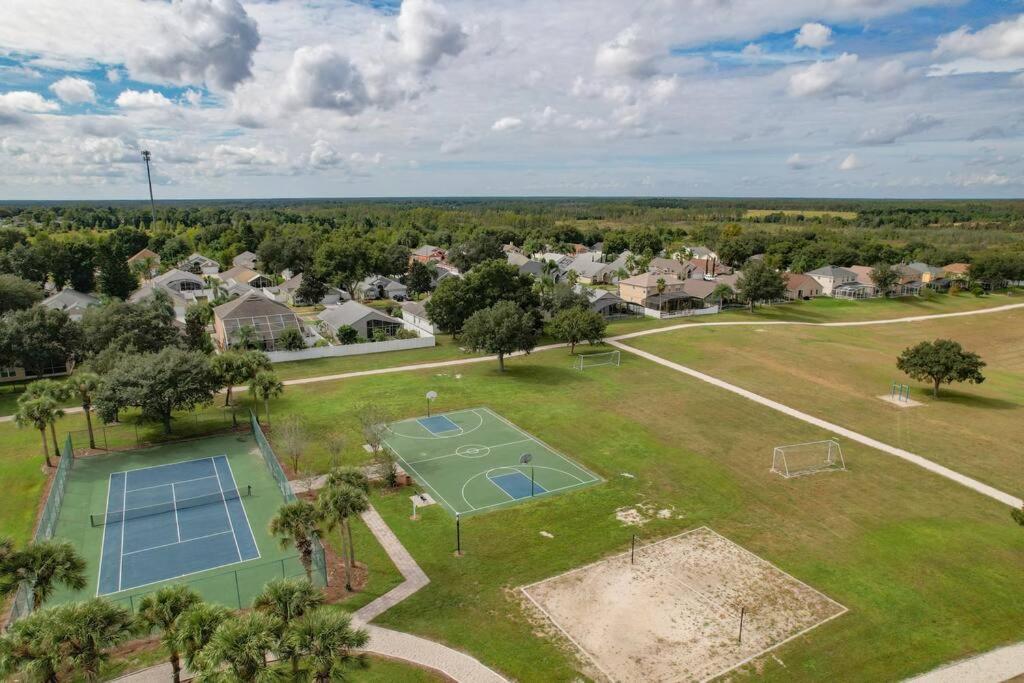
[54,598,134,681]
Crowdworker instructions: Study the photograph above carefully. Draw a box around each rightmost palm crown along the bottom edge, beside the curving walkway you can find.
[288,607,370,683]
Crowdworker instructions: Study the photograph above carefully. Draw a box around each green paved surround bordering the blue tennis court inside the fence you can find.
[52,434,311,610]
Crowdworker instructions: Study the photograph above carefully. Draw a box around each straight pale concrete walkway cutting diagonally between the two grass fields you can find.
[608,340,1024,508]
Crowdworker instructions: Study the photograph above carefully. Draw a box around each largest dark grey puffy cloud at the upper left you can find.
[127,0,260,90]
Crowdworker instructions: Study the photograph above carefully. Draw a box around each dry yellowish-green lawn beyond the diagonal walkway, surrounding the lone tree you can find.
[629,309,1024,496]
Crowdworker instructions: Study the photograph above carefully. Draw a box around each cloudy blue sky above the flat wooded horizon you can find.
[0,0,1024,200]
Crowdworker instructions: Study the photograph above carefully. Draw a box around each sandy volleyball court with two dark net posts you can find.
[522,527,846,681]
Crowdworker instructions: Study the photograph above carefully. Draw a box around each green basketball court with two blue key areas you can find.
[384,408,601,515]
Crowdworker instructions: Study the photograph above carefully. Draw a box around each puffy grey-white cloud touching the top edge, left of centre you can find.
[396,0,468,69]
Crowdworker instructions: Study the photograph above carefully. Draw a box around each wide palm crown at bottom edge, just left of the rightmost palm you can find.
[196,611,283,683]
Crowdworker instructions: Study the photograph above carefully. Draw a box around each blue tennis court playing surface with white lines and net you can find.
[93,456,260,595]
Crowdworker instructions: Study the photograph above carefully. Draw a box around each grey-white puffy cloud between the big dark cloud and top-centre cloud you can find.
[285,45,372,116]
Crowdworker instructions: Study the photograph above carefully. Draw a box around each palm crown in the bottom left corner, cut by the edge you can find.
[0,609,63,683]
